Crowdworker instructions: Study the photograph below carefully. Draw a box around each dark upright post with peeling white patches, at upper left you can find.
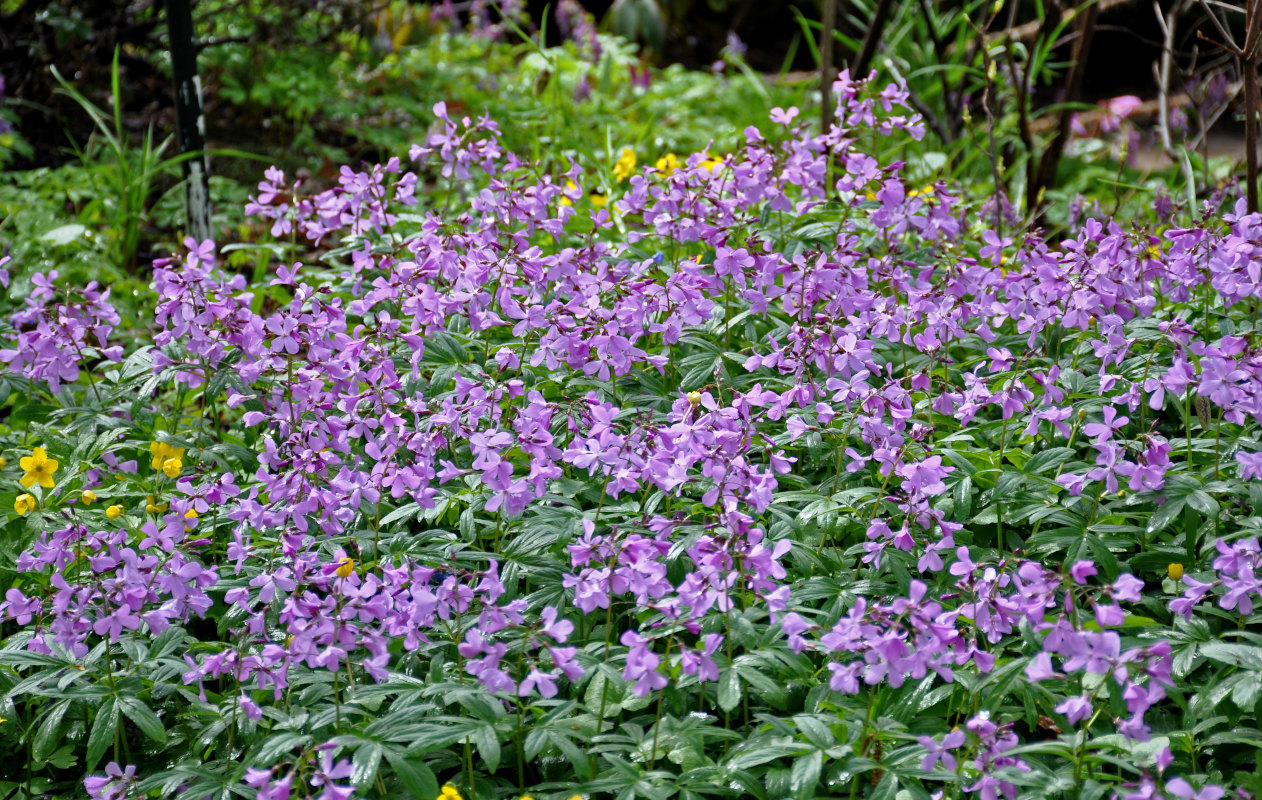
[165,0,213,242]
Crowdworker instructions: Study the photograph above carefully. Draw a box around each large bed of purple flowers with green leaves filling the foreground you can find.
[0,24,1262,800]
